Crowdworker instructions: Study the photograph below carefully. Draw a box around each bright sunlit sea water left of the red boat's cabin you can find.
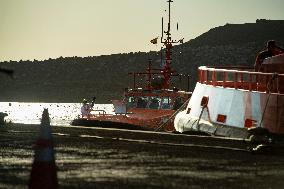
[0,102,113,125]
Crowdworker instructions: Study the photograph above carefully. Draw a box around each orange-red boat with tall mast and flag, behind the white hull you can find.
[71,0,191,131]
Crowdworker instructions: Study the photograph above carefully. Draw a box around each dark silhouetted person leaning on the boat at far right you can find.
[254,40,284,72]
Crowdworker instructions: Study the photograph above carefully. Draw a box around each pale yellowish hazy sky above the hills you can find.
[0,0,284,61]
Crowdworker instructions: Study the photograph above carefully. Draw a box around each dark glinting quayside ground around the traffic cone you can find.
[0,125,284,189]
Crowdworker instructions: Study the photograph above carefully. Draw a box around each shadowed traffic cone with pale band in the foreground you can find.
[29,109,58,189]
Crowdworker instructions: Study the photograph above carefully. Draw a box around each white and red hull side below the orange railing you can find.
[174,83,284,134]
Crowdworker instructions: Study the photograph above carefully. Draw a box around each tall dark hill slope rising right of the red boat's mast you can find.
[172,20,284,85]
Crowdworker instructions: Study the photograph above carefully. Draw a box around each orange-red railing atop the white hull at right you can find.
[198,66,284,94]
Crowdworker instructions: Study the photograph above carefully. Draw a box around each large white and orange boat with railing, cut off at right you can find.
[174,54,284,142]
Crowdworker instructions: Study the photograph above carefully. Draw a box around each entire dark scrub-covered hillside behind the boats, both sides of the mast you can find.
[0,20,284,103]
